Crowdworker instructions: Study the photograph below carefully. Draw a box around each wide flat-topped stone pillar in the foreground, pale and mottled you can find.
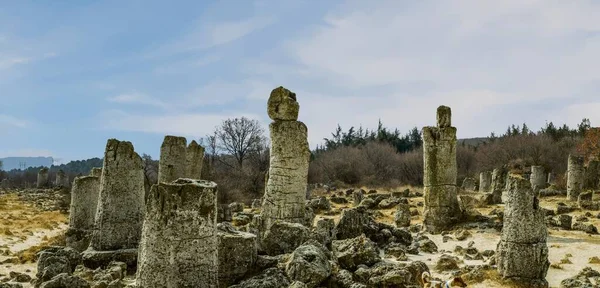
[137,179,219,288]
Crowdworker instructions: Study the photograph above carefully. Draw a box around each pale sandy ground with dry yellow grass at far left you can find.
[0,193,68,287]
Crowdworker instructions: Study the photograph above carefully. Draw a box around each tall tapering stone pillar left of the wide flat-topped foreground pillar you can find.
[90,139,144,251]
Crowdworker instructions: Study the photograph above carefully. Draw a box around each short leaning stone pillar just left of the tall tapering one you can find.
[66,176,100,251]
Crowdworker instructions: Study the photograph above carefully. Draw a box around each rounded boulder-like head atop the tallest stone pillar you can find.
[267,86,300,121]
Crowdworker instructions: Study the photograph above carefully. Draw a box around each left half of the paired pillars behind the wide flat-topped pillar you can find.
[158,135,187,183]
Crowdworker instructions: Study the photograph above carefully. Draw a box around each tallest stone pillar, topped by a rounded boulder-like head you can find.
[261,87,310,227]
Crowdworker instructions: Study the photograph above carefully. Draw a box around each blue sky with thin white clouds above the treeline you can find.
[0,0,600,161]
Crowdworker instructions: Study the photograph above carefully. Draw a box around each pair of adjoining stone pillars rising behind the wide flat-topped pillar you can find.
[158,135,204,183]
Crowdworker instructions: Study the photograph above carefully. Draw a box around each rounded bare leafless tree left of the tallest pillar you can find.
[215,117,265,168]
